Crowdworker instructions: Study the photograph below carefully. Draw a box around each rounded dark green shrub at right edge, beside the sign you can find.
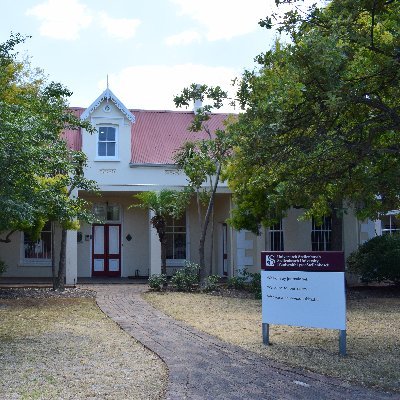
[347,234,400,284]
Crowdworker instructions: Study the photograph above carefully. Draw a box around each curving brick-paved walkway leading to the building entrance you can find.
[90,285,399,400]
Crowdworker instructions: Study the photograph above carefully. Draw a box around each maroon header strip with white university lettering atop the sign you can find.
[261,251,344,272]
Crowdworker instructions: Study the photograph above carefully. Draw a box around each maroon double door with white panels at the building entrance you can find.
[92,224,121,276]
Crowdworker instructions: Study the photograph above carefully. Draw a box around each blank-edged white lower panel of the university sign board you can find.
[261,271,346,330]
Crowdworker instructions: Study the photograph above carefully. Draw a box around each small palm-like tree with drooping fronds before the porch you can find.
[130,189,191,275]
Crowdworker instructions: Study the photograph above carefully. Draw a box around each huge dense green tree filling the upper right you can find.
[228,0,400,249]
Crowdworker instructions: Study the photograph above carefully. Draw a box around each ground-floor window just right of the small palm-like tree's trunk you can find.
[166,215,186,266]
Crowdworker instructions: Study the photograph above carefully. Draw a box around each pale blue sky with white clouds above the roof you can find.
[0,0,318,111]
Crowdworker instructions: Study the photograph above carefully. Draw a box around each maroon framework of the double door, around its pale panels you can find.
[91,223,122,277]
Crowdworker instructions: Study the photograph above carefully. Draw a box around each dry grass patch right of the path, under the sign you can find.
[144,292,400,392]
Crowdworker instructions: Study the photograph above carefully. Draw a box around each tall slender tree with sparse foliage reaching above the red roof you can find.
[174,84,231,282]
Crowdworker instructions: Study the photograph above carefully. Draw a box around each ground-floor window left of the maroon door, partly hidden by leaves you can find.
[22,222,52,266]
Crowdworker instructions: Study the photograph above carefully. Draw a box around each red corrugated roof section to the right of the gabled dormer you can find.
[130,110,227,164]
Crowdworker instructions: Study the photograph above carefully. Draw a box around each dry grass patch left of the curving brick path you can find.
[0,298,167,400]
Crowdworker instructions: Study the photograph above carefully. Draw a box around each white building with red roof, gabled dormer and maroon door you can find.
[0,89,399,284]
